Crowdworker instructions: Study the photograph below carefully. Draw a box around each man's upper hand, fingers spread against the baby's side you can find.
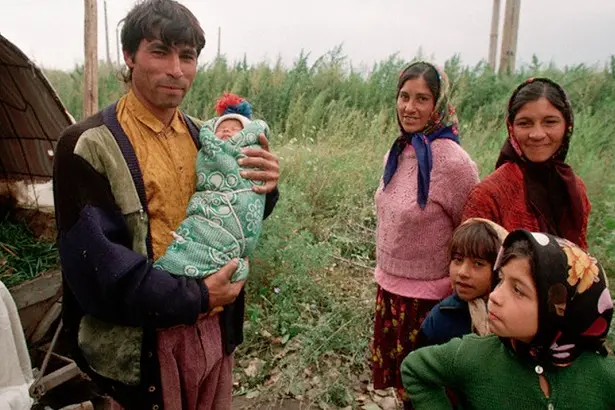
[237,134,280,194]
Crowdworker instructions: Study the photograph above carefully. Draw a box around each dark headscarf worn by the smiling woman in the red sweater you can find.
[496,78,585,248]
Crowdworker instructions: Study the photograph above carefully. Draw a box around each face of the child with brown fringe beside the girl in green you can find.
[448,254,492,302]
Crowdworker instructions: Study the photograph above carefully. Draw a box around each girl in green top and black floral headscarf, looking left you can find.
[402,230,615,410]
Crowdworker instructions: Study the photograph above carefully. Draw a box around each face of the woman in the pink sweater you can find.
[397,78,436,133]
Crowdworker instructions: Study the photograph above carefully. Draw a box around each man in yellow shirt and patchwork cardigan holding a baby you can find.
[54,0,279,409]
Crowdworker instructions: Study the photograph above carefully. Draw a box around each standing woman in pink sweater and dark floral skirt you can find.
[372,62,478,406]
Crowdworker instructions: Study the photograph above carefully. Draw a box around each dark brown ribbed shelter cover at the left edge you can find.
[0,35,73,181]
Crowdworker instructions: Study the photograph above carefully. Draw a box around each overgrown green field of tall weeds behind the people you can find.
[35,52,615,408]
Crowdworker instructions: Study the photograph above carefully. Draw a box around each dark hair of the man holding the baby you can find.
[121,0,205,82]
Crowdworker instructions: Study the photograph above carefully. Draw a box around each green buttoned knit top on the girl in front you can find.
[401,335,615,410]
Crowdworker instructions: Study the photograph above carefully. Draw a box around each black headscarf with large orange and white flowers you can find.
[496,230,613,367]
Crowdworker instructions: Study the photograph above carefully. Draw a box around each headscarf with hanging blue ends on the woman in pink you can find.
[383,61,459,209]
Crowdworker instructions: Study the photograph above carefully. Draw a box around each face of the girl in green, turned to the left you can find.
[487,258,538,343]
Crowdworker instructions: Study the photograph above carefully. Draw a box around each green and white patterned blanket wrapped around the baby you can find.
[154,118,269,282]
